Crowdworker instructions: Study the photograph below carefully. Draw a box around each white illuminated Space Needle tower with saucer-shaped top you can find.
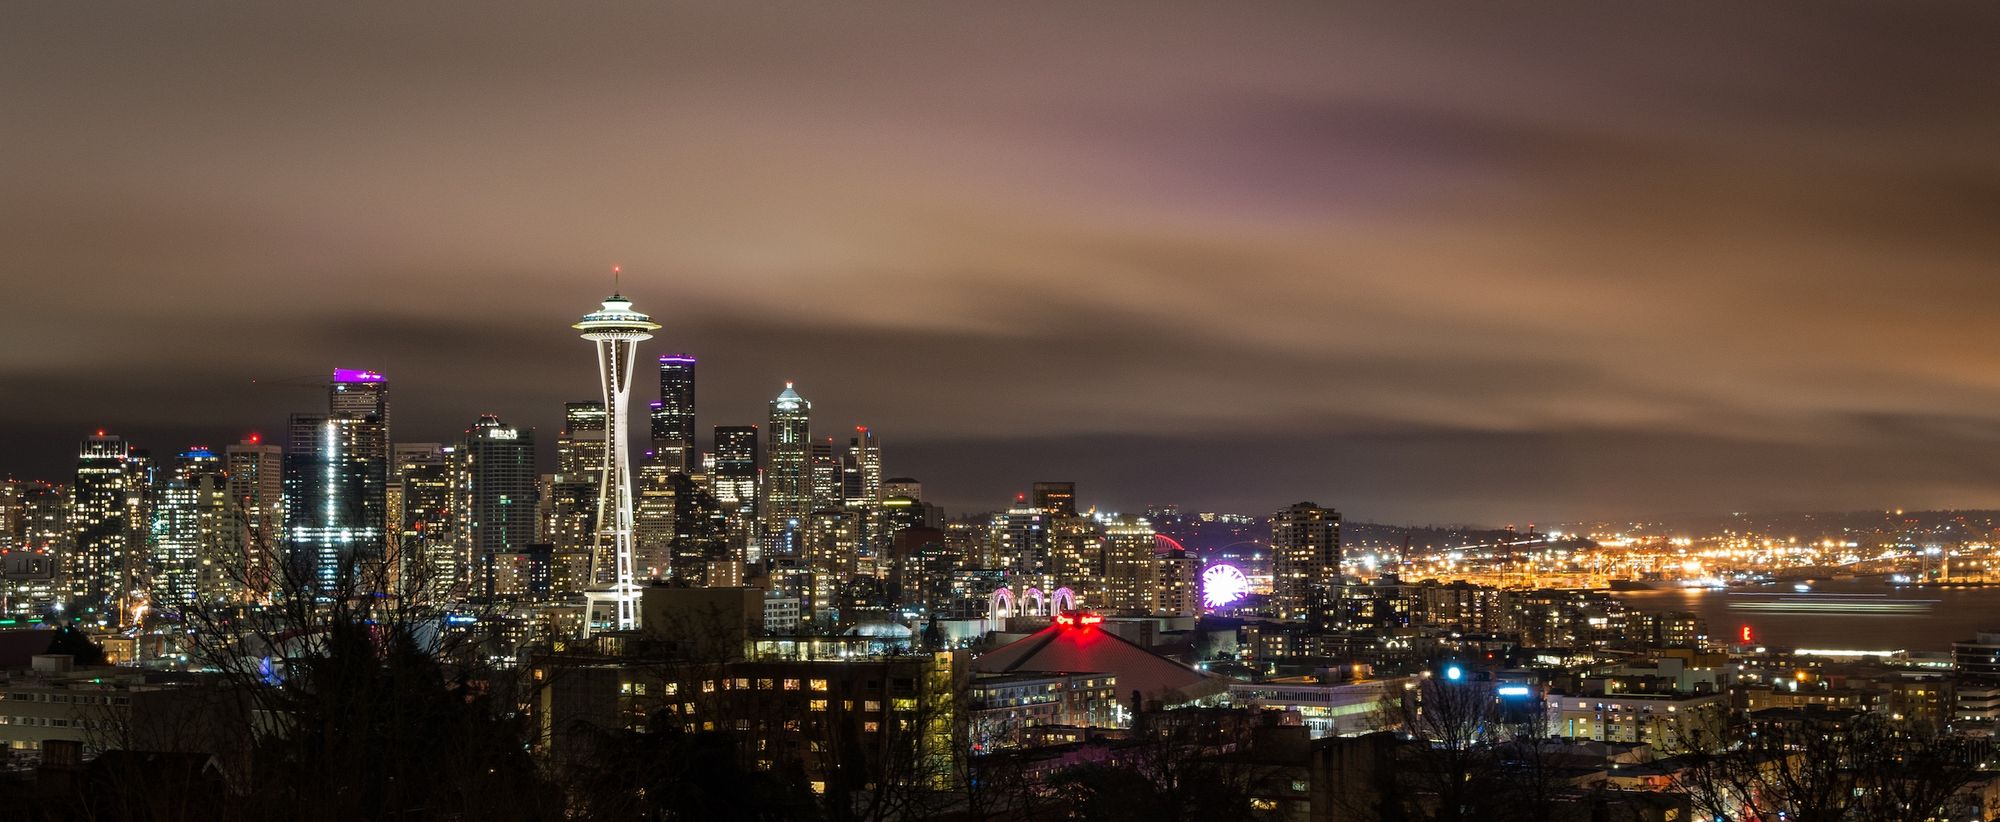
[570,266,660,632]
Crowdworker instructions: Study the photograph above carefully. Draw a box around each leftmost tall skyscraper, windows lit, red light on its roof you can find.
[64,430,144,624]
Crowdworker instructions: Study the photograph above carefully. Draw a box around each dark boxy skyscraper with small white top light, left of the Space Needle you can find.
[456,414,536,598]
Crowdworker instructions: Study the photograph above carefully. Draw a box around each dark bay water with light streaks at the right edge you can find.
[1616,576,2000,652]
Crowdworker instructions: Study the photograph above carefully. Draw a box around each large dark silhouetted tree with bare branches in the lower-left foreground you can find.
[168,532,562,820]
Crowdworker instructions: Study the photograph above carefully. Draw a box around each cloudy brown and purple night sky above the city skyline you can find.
[0,2,2000,524]
